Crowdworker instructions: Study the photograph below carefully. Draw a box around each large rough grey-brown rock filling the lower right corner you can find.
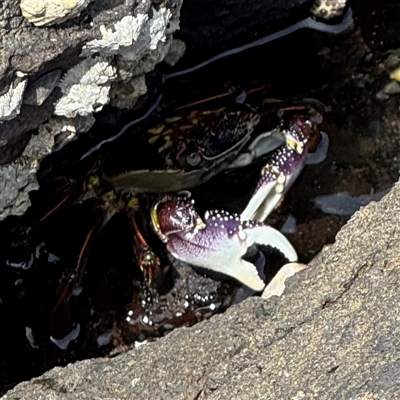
[3,183,400,400]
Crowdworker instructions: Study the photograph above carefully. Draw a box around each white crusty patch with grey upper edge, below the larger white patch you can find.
[54,57,117,118]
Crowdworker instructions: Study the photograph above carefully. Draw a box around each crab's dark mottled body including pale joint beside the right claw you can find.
[103,99,285,194]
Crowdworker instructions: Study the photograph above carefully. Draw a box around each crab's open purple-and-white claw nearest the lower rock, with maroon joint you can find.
[151,196,297,291]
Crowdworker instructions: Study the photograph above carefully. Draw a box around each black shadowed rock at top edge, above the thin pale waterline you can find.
[175,0,314,63]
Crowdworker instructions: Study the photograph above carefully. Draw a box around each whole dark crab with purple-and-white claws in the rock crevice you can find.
[1,95,320,348]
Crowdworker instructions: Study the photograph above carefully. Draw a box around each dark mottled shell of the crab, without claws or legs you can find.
[104,106,260,193]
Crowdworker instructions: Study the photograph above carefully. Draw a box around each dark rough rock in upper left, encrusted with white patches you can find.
[0,0,182,220]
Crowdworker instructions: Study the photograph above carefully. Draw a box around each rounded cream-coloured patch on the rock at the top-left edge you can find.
[20,0,91,26]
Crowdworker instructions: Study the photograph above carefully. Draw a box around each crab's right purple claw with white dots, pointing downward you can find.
[240,109,322,222]
